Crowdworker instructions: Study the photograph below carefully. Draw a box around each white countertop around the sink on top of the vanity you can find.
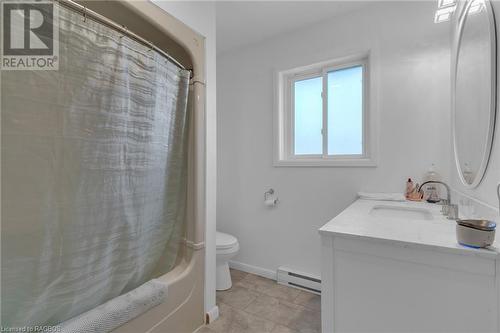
[319,199,500,259]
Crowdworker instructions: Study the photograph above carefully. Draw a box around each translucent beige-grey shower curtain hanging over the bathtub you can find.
[1,3,189,327]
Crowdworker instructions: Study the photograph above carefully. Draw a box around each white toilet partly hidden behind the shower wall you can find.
[215,231,240,290]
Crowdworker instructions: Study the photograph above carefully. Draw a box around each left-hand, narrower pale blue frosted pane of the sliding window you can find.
[294,77,323,155]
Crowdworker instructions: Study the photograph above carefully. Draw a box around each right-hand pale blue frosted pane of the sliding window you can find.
[328,66,363,155]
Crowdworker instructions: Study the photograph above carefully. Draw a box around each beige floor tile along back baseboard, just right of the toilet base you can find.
[237,274,300,302]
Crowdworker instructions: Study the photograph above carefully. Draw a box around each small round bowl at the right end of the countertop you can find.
[456,220,497,249]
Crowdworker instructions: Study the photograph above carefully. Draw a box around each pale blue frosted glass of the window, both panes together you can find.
[294,66,363,155]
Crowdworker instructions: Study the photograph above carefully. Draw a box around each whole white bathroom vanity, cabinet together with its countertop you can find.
[320,200,500,333]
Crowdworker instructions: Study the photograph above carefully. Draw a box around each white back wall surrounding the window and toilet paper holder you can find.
[217,1,450,275]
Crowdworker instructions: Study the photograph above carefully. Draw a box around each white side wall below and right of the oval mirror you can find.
[450,1,500,219]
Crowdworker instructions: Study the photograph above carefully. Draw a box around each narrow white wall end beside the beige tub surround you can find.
[153,0,217,312]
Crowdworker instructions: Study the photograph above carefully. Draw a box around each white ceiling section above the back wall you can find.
[216,1,366,54]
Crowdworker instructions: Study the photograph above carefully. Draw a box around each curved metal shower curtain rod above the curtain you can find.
[55,0,192,71]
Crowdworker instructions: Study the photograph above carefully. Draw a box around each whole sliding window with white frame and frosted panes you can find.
[275,56,375,166]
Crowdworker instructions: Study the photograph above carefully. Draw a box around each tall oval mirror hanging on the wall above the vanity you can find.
[452,0,496,188]
